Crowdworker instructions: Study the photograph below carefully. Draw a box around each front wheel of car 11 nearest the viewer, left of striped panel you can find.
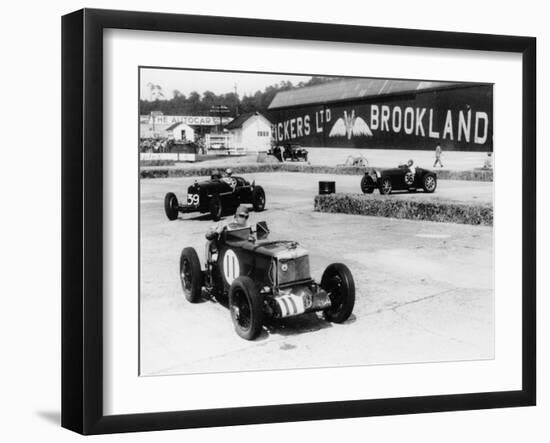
[229,275,264,340]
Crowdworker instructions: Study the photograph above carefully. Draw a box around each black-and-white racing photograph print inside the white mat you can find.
[136,66,496,376]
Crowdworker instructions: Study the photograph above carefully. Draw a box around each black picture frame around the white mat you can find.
[62,9,536,434]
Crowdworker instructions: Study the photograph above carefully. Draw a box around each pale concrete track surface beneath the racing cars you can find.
[140,173,494,375]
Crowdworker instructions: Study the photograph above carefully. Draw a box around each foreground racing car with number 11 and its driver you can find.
[180,222,355,340]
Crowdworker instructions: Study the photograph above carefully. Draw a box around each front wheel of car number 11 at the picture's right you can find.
[321,263,355,323]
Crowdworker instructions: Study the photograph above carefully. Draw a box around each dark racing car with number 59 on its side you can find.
[164,174,265,221]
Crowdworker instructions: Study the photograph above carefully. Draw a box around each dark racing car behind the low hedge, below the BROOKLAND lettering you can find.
[361,165,437,195]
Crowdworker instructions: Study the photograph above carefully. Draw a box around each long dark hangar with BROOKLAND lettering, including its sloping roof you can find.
[268,78,493,152]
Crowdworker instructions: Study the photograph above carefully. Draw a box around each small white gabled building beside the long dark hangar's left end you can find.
[225,112,271,152]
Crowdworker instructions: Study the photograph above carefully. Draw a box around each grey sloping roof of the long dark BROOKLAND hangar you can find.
[268,78,468,109]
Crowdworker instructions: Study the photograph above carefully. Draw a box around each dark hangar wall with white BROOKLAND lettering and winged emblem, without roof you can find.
[272,87,493,151]
